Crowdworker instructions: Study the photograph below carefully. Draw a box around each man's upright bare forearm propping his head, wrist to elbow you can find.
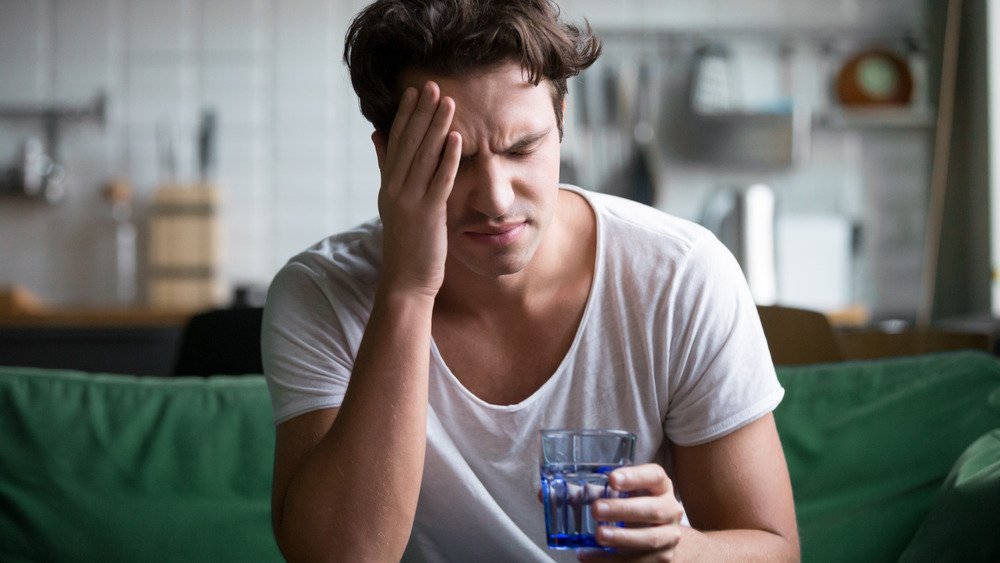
[276,292,433,560]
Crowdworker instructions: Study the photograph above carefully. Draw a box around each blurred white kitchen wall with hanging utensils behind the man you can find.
[0,0,991,328]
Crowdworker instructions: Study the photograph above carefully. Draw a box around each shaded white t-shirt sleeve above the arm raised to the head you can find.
[261,262,363,424]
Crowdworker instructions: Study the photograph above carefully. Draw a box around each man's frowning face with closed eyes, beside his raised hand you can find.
[400,63,559,276]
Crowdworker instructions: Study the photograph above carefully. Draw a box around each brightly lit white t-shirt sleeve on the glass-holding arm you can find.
[664,233,784,445]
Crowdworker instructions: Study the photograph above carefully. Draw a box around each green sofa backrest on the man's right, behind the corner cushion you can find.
[775,352,1000,562]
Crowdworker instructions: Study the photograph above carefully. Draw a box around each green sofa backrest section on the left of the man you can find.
[0,368,281,562]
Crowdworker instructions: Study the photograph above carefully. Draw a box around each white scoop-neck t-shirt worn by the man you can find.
[262,186,784,561]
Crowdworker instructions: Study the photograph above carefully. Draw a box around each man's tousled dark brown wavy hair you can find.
[344,0,601,139]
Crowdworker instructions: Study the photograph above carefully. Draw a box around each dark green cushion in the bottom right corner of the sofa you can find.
[900,430,1000,561]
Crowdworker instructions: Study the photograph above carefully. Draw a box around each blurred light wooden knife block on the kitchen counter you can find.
[149,185,224,311]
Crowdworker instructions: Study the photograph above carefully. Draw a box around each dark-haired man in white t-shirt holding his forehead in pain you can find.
[262,0,798,561]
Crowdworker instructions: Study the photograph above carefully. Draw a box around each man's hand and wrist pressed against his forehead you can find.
[372,82,462,297]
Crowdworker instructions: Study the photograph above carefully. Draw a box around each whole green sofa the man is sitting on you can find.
[0,352,1000,562]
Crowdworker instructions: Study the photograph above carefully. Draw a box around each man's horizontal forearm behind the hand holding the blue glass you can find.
[674,526,801,562]
